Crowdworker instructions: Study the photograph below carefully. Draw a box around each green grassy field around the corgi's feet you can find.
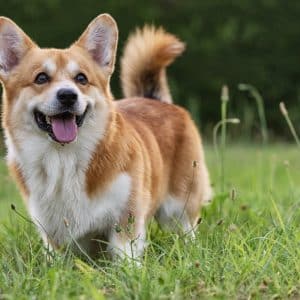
[0,145,300,299]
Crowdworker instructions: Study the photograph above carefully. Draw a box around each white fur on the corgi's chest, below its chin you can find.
[6,134,131,245]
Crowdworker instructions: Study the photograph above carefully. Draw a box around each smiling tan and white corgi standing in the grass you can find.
[0,14,212,258]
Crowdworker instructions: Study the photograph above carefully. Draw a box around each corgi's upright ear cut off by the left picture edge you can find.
[0,17,35,81]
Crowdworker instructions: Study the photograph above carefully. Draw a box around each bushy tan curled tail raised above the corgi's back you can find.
[121,25,185,103]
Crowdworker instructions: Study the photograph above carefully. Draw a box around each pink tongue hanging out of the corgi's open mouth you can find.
[51,116,77,143]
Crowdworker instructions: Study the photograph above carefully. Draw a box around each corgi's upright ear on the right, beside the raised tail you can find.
[74,14,118,77]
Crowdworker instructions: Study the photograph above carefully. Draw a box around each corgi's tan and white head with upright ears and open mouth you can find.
[0,14,118,144]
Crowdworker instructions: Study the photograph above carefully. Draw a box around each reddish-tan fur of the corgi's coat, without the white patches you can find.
[0,17,211,258]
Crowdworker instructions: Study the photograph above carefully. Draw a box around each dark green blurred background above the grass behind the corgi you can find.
[0,0,300,140]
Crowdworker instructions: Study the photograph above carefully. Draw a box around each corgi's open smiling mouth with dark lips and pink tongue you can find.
[34,107,88,144]
